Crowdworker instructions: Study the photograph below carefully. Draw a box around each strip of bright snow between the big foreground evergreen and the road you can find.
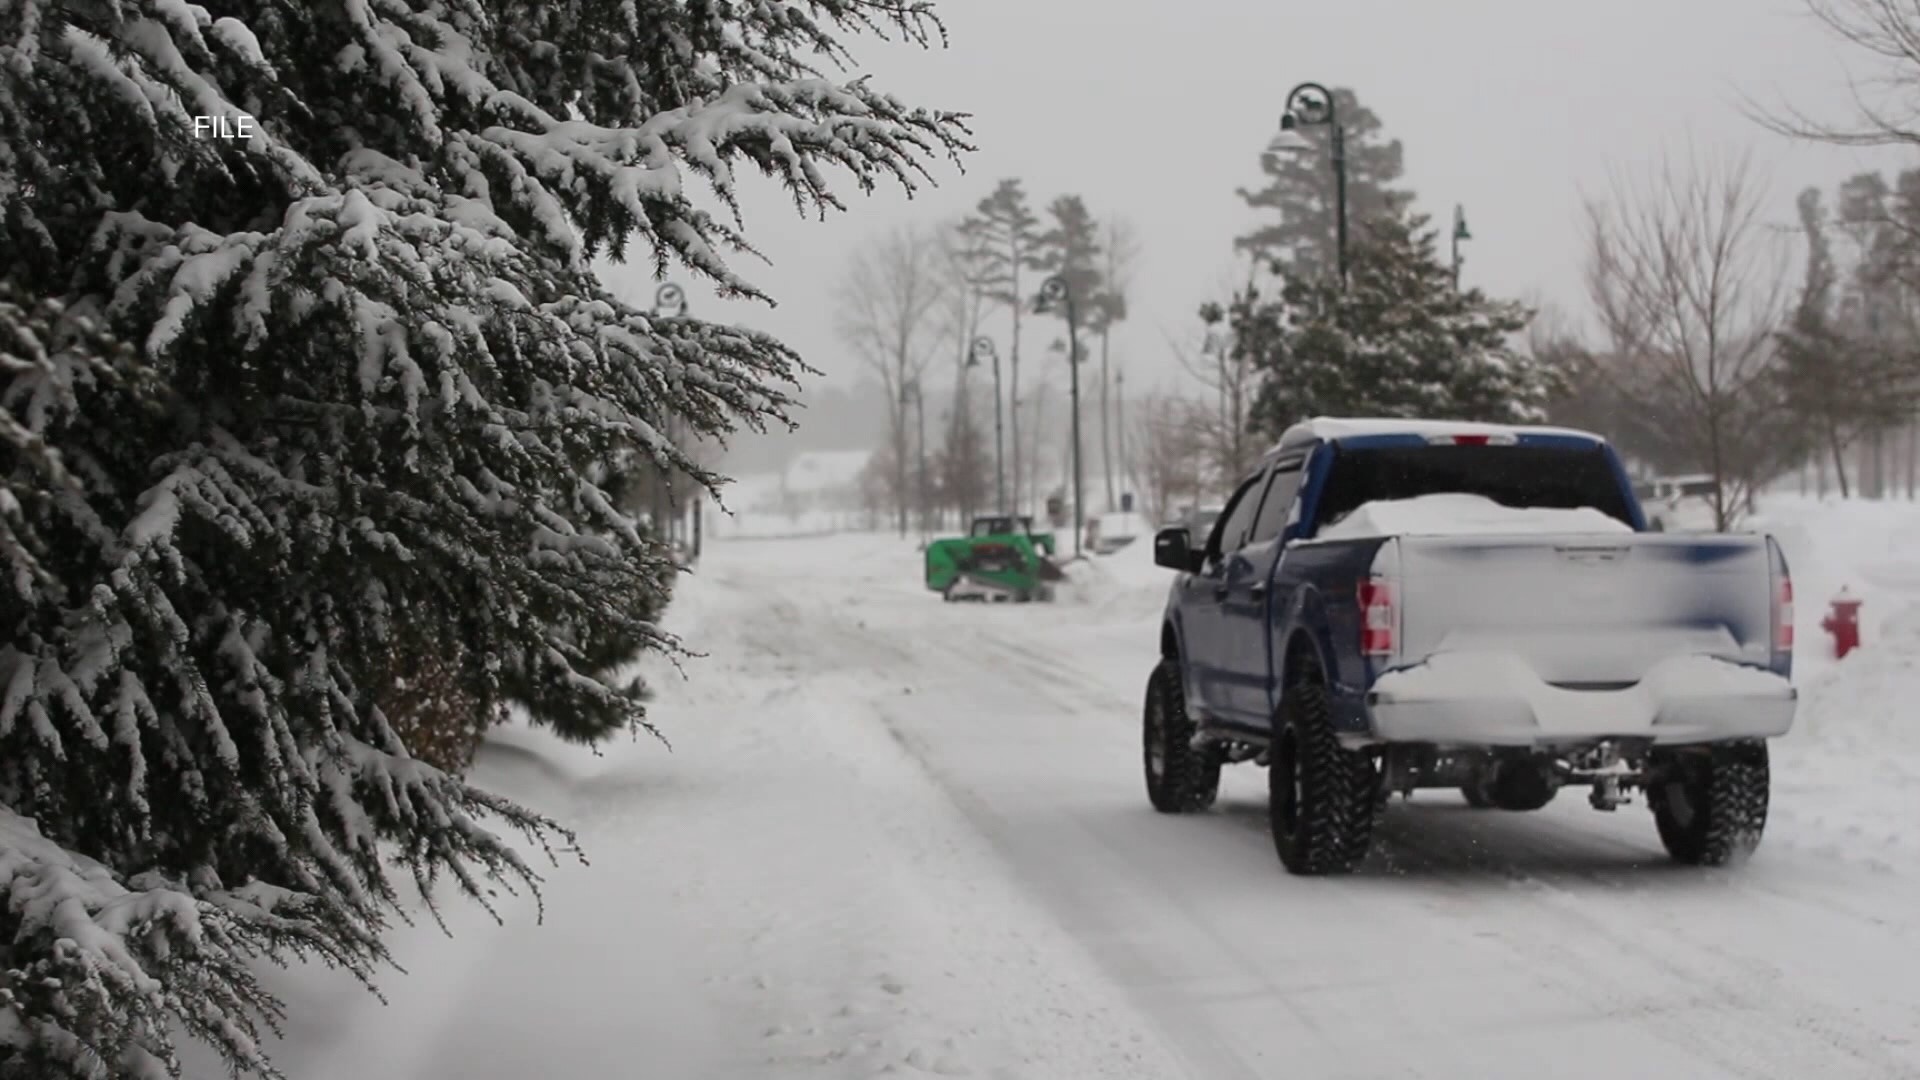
[255,534,1183,1080]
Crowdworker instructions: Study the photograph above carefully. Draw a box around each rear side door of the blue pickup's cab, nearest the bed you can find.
[1215,452,1308,728]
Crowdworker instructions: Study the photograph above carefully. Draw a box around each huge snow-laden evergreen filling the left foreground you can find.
[0,0,964,1078]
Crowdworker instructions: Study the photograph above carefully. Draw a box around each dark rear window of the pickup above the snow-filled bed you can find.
[1313,446,1634,528]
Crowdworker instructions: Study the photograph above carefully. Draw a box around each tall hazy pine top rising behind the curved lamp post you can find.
[1235,88,1413,279]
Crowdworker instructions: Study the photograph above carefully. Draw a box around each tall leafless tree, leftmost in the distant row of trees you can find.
[837,227,947,536]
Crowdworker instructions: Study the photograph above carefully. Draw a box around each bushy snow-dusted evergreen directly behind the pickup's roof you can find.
[1225,217,1551,438]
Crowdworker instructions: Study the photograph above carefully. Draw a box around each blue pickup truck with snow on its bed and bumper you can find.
[1142,419,1795,874]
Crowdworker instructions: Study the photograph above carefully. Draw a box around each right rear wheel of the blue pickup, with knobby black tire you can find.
[1647,742,1770,867]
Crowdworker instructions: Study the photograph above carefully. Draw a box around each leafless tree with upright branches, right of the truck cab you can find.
[1586,146,1805,530]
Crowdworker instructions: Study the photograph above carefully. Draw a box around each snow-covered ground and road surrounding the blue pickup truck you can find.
[263,500,1920,1080]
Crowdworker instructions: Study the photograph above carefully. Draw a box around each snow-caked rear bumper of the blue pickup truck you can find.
[1367,653,1799,746]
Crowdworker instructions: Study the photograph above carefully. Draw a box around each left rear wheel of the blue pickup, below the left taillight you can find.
[1267,671,1380,874]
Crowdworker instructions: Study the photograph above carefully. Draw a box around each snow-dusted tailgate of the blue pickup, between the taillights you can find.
[1375,532,1774,690]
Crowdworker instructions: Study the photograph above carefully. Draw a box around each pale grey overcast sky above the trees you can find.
[609,0,1914,399]
